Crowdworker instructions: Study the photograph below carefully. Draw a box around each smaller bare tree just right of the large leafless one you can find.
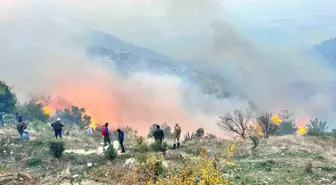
[257,112,278,138]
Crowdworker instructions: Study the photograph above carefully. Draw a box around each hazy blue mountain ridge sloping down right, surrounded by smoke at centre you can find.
[87,31,230,98]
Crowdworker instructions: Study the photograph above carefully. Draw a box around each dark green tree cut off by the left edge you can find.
[0,81,17,113]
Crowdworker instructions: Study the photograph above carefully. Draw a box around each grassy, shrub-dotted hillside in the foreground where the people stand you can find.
[0,123,336,185]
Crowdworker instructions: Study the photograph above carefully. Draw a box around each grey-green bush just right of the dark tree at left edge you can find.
[17,100,49,122]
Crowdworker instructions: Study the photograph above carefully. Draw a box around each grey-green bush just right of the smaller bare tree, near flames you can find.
[276,110,297,136]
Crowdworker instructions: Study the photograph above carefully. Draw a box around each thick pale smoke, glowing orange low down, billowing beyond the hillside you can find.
[0,0,335,133]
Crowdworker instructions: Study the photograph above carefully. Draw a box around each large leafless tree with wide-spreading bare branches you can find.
[217,109,252,139]
